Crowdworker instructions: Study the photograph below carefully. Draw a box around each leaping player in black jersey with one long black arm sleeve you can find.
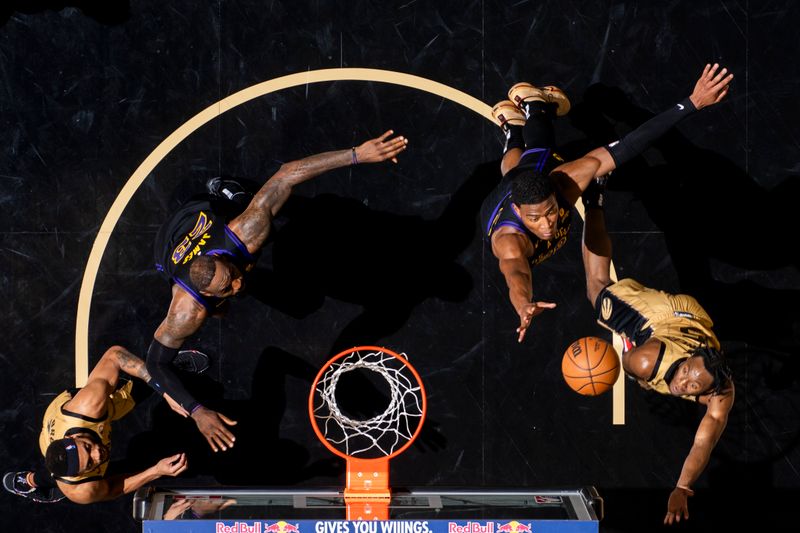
[482,64,733,342]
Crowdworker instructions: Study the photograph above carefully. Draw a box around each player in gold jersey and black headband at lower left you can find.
[3,346,188,503]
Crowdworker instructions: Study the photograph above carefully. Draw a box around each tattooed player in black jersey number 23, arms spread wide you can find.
[147,130,408,452]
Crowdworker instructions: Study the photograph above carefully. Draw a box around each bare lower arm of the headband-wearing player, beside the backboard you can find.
[57,453,189,503]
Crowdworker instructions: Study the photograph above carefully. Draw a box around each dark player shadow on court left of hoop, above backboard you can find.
[126,348,341,486]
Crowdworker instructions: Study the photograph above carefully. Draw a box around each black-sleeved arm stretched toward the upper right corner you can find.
[554,63,733,202]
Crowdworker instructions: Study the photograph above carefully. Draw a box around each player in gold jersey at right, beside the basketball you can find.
[582,195,734,524]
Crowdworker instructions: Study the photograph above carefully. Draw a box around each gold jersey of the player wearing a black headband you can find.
[39,381,134,484]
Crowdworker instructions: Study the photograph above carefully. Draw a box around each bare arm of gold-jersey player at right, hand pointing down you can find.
[664,384,734,524]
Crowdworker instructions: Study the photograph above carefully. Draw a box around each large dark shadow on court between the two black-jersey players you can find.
[247,162,500,353]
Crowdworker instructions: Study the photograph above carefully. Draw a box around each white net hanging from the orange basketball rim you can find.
[313,349,425,459]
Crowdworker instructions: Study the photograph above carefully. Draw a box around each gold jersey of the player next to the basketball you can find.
[596,278,720,400]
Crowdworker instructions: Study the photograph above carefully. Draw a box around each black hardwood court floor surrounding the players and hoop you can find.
[0,0,800,533]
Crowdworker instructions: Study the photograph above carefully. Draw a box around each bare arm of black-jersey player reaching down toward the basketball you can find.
[492,230,556,342]
